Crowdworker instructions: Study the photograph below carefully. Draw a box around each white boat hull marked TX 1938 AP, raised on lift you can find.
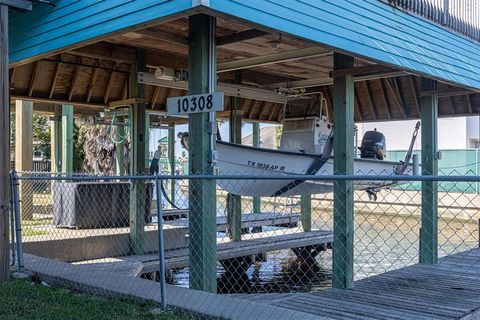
[217,142,412,197]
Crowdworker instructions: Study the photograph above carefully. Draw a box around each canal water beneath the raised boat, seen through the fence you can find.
[167,210,479,293]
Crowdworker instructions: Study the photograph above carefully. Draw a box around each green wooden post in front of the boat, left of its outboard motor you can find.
[333,53,355,288]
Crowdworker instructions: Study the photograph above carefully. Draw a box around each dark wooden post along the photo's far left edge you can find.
[0,5,10,282]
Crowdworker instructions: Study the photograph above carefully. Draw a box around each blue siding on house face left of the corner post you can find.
[10,0,192,63]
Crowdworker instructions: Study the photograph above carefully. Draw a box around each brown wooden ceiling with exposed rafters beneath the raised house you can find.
[10,18,480,122]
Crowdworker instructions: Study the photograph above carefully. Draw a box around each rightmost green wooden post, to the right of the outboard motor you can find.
[420,78,438,264]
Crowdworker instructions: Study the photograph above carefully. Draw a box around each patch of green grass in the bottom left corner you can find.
[0,280,187,320]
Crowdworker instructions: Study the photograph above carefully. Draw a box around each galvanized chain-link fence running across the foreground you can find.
[8,173,480,319]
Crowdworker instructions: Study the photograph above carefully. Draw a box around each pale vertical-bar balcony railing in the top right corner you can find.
[380,0,480,41]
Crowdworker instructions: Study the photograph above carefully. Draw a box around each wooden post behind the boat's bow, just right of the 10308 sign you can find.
[227,79,243,241]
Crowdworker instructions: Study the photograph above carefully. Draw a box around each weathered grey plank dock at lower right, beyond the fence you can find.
[234,248,480,320]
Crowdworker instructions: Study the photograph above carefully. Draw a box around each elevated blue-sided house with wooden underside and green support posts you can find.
[0,0,480,300]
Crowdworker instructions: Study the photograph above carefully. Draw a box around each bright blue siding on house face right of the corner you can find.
[210,0,480,89]
